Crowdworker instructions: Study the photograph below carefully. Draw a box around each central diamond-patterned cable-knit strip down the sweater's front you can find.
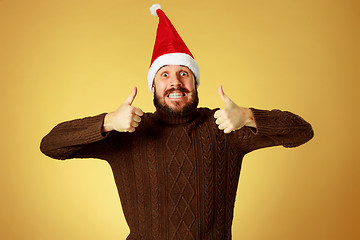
[166,128,197,239]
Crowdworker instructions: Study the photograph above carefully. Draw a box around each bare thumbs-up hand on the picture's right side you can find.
[214,85,256,133]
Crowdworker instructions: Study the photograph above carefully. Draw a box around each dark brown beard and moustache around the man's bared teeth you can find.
[154,87,199,116]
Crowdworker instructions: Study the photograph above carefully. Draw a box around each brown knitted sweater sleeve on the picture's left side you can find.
[40,113,107,160]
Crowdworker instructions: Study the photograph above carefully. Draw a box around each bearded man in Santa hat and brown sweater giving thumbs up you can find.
[40,6,313,239]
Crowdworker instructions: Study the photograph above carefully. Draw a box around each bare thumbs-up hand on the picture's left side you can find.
[102,87,144,132]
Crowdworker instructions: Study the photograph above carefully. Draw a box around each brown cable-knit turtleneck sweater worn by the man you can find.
[40,108,313,240]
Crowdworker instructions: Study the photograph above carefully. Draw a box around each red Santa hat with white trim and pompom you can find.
[148,4,200,92]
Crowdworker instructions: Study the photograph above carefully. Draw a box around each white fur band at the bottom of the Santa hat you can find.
[148,53,200,92]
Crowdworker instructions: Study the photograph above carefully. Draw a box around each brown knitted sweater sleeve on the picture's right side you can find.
[242,108,314,152]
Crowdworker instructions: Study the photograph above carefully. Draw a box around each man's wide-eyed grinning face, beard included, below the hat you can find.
[153,65,199,115]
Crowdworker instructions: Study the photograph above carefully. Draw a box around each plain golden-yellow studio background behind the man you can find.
[0,0,360,240]
